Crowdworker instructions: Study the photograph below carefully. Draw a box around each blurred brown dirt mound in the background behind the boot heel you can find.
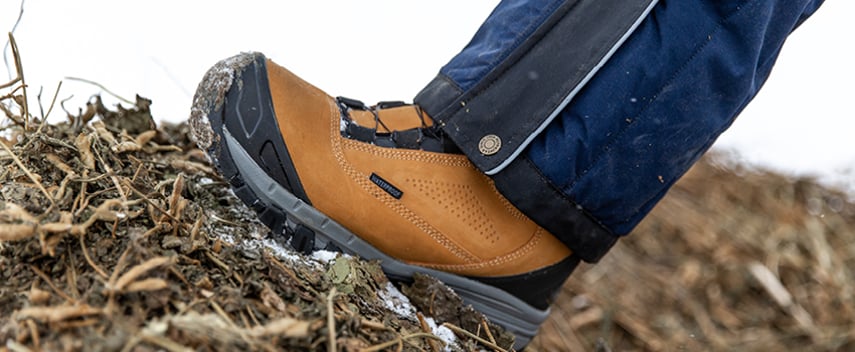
[532,156,855,351]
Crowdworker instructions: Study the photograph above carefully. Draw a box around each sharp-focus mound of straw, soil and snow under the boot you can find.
[0,89,513,351]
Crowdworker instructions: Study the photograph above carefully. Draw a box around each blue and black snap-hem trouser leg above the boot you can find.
[415,0,822,261]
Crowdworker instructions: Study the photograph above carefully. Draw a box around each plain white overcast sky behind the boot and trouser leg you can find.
[5,0,855,190]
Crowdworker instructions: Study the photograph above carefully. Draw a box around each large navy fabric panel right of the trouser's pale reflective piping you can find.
[527,0,820,235]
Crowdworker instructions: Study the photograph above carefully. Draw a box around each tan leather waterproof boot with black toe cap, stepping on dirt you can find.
[191,53,578,347]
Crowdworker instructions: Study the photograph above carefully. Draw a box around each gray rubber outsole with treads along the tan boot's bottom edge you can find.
[220,126,549,349]
